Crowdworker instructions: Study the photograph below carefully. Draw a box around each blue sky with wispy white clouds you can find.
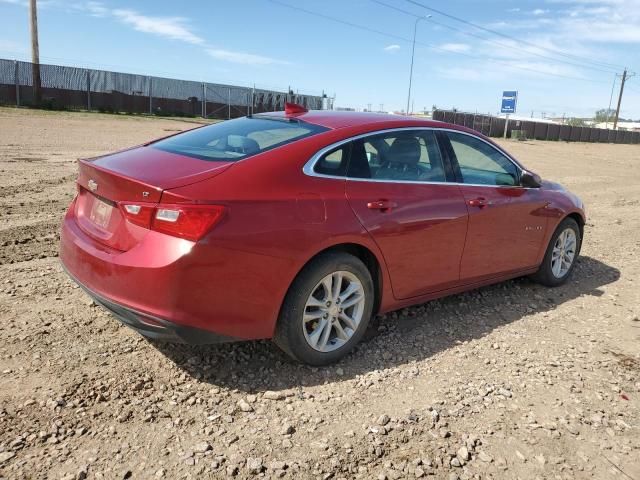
[0,0,640,119]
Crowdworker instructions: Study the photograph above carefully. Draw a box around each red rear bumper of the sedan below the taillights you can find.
[60,199,290,343]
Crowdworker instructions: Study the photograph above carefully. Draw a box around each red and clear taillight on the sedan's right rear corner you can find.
[120,202,224,242]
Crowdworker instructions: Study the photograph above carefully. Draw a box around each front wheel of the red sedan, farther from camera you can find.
[531,218,582,287]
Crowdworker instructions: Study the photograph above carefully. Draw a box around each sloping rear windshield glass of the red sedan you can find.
[149,117,327,162]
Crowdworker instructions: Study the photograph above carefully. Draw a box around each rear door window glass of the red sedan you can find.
[348,130,445,182]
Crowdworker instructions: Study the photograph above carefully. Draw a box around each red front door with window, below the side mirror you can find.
[439,131,547,283]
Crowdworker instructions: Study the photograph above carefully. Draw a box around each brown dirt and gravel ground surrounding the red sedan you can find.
[0,109,640,480]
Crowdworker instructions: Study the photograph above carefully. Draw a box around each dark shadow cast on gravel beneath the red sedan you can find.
[153,257,620,393]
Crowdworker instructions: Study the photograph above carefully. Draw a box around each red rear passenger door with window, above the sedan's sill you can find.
[346,129,467,299]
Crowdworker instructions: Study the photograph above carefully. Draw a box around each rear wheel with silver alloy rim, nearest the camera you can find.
[273,252,375,366]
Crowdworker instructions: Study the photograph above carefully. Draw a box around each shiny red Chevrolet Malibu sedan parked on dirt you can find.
[60,105,585,365]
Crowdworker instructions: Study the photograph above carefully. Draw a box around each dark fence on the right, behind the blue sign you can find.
[433,110,640,143]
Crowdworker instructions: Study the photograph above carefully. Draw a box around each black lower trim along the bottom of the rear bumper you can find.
[62,264,238,345]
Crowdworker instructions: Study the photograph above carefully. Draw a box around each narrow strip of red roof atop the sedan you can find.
[255,110,447,129]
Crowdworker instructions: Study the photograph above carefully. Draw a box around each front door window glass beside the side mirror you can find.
[447,132,519,186]
